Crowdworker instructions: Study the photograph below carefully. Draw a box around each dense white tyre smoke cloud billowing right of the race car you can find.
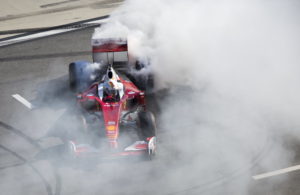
[93,0,300,194]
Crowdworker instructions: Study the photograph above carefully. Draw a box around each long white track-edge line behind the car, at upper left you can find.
[0,18,108,47]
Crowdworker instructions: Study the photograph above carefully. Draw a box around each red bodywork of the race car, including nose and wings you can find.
[69,39,155,157]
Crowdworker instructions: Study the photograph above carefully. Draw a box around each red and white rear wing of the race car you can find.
[92,38,128,64]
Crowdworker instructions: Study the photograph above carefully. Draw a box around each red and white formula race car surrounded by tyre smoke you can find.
[68,39,156,159]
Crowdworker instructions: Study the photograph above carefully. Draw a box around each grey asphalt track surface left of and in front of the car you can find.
[0,28,300,195]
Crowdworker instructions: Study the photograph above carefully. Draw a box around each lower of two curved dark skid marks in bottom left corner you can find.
[0,144,53,195]
